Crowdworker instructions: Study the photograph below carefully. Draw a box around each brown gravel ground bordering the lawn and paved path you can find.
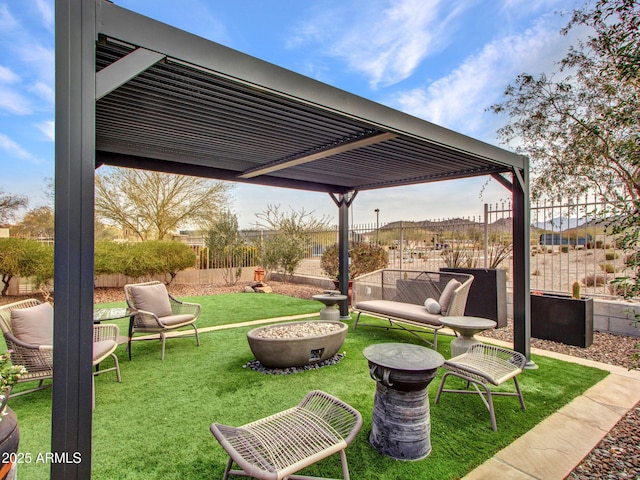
[0,282,640,480]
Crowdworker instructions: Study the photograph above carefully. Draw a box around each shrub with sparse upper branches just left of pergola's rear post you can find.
[256,205,329,276]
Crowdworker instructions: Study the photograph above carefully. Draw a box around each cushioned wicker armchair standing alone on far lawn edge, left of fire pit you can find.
[124,282,200,360]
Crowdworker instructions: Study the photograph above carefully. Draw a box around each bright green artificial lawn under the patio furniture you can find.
[9,294,607,480]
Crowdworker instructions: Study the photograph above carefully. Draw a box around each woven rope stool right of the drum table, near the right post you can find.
[434,344,527,432]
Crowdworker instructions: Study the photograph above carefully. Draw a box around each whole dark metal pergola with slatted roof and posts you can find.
[51,0,530,479]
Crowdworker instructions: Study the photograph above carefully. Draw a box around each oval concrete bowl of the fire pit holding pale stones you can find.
[247,320,347,368]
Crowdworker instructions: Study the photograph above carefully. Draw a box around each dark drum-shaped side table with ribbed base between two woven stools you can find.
[363,343,444,460]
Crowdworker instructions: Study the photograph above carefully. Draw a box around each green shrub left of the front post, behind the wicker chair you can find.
[0,238,53,296]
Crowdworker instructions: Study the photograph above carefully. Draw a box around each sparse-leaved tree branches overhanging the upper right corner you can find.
[491,0,640,201]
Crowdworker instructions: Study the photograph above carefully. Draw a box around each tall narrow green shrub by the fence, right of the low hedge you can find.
[206,211,244,285]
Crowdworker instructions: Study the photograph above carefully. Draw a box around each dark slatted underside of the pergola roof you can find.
[96,36,519,193]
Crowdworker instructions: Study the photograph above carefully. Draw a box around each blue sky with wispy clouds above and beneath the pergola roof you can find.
[0,0,584,227]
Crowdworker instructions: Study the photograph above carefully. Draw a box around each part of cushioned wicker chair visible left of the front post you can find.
[0,299,53,397]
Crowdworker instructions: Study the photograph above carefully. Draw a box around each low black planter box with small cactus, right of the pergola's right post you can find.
[531,293,593,348]
